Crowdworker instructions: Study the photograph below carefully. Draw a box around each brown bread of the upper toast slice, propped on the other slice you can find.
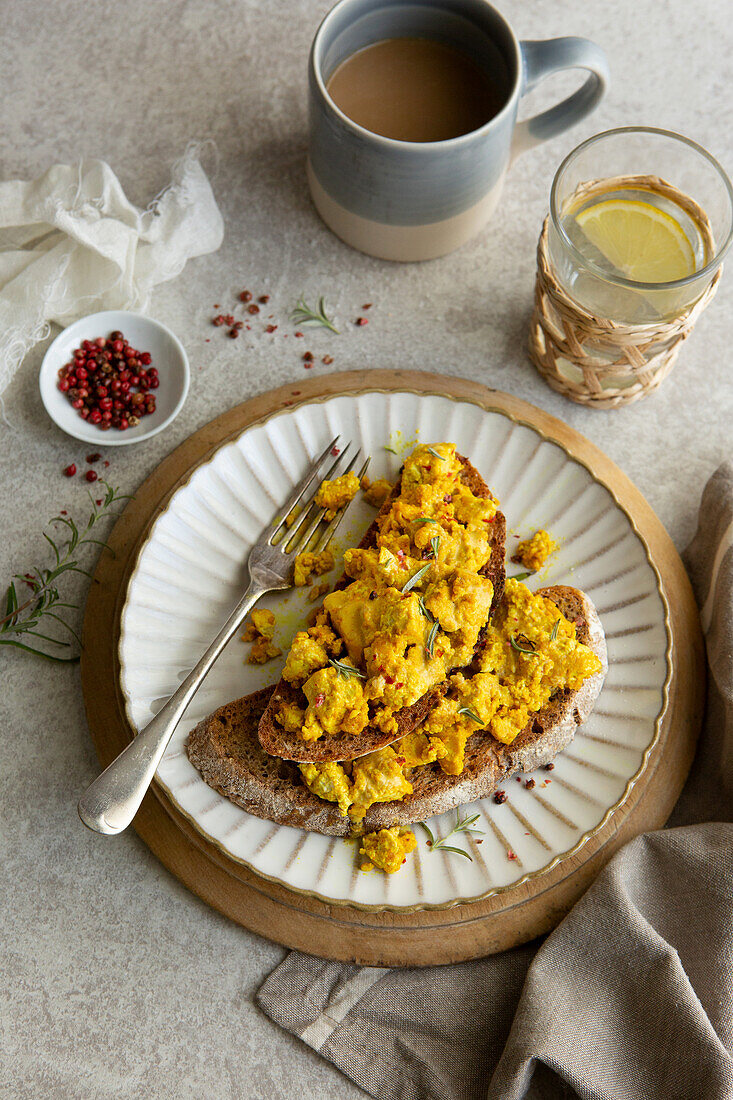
[258,454,506,761]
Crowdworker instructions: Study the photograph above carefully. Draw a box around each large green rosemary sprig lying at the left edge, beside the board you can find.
[0,482,129,663]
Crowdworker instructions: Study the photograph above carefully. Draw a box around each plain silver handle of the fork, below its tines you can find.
[78,581,267,836]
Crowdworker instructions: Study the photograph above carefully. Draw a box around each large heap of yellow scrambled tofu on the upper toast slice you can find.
[278,443,497,740]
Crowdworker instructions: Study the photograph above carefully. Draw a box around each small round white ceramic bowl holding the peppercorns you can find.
[39,309,190,447]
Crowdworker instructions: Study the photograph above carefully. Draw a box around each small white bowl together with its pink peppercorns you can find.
[39,309,190,447]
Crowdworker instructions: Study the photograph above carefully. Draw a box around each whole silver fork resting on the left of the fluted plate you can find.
[78,436,369,835]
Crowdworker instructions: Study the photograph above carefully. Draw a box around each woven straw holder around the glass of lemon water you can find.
[529,210,722,409]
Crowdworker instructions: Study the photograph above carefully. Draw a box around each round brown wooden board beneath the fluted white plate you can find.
[81,371,705,966]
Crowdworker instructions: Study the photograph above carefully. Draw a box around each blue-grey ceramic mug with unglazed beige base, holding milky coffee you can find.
[307,0,609,261]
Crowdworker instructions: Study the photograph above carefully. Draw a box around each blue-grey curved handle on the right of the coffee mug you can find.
[512,37,611,160]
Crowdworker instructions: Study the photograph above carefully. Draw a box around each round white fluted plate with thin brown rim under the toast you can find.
[120,392,670,909]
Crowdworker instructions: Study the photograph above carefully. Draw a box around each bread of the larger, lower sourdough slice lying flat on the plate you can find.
[187,585,608,836]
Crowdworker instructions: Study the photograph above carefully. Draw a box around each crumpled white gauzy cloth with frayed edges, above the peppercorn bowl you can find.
[0,144,223,398]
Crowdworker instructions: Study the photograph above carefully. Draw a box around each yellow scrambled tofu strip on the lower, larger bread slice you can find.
[299,580,601,822]
